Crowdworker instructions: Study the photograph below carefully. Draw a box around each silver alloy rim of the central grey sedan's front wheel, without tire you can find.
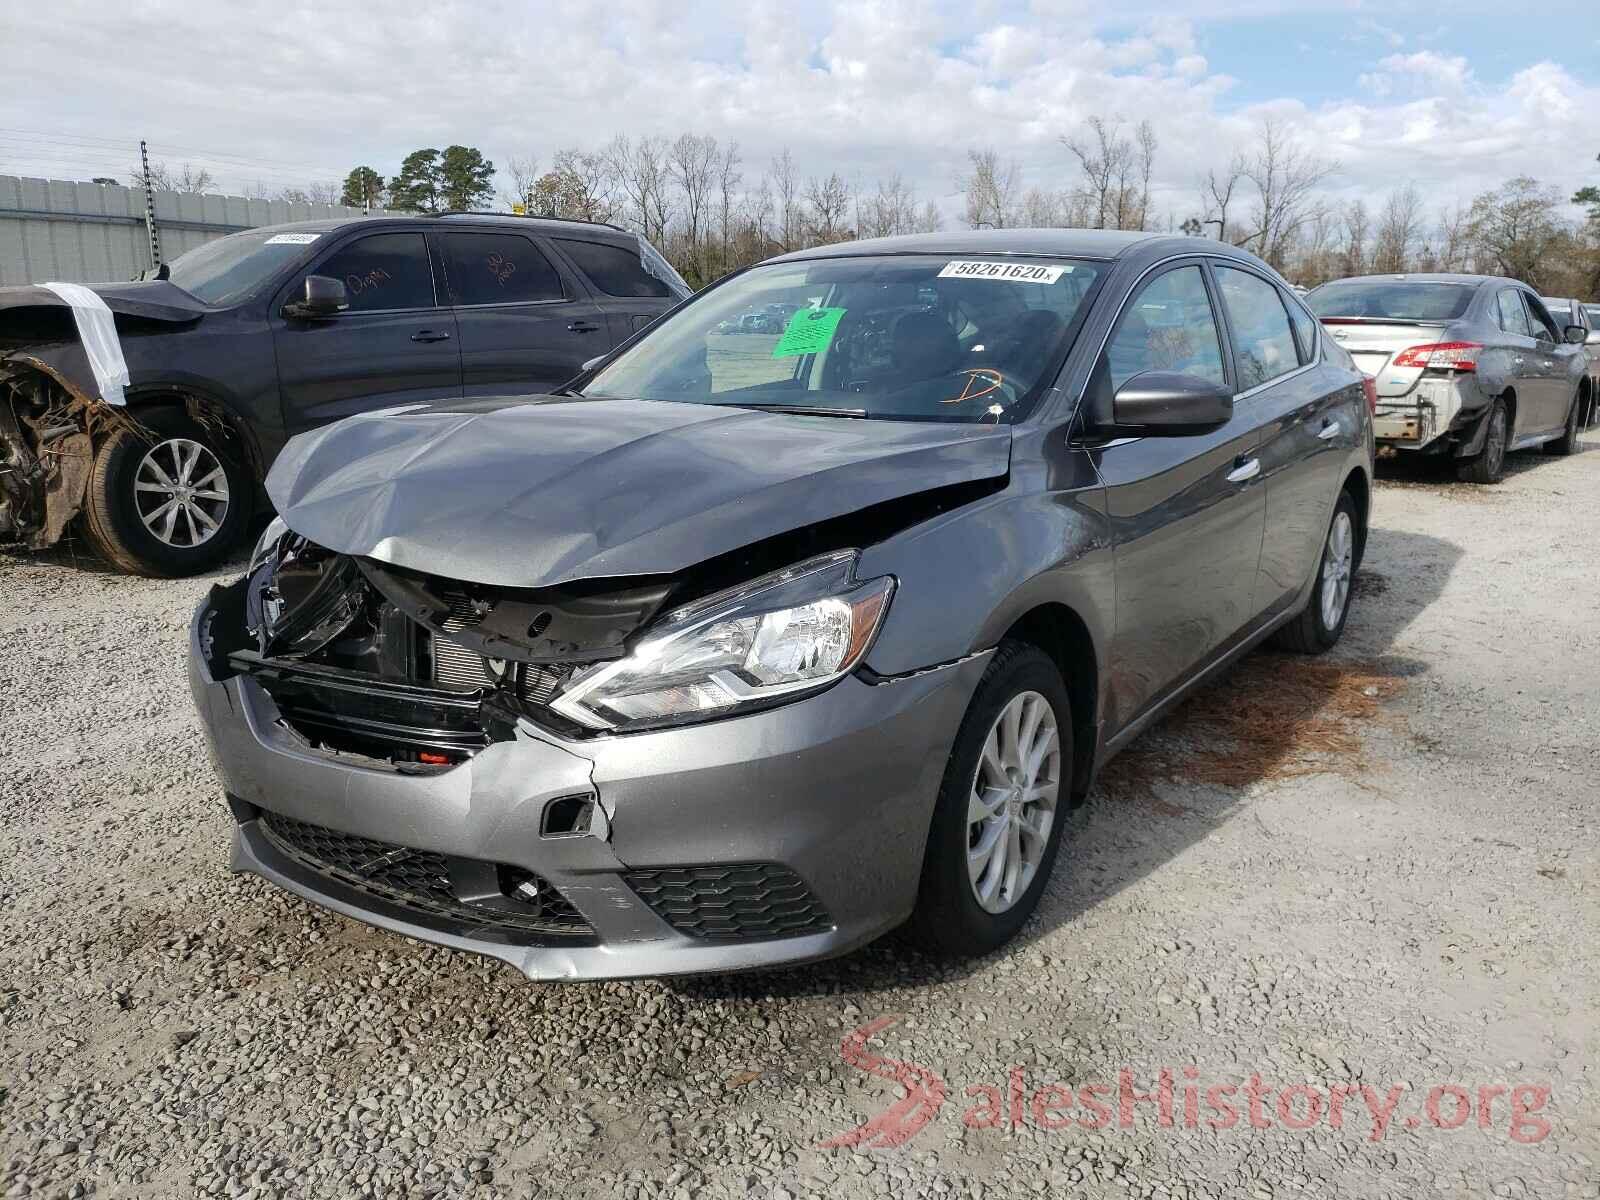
[966,691,1061,914]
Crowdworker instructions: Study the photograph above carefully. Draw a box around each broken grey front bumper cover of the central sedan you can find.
[189,605,989,979]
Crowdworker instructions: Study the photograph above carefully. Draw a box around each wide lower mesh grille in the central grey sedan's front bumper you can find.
[261,813,594,942]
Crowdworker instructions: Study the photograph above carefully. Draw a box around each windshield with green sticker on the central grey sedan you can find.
[581,254,1106,424]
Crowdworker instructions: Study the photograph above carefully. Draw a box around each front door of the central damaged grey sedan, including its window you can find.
[1091,259,1266,720]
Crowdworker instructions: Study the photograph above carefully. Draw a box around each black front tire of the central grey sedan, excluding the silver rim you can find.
[906,642,1072,957]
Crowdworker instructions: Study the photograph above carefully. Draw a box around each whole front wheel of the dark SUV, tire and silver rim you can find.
[83,413,251,576]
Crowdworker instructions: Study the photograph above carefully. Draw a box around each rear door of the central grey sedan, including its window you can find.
[1211,261,1366,614]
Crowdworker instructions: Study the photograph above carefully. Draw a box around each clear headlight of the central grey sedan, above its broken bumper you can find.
[550,550,894,730]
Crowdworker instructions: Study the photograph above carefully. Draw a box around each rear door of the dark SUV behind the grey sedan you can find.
[432,229,608,395]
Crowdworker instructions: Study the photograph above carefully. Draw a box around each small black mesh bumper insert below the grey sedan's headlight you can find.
[624,862,834,941]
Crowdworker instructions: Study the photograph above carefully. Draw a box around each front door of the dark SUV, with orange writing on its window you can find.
[269,230,461,434]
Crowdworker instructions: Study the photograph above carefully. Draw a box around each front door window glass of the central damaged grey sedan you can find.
[1106,267,1227,390]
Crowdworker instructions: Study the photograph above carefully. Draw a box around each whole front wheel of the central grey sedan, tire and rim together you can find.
[907,642,1072,955]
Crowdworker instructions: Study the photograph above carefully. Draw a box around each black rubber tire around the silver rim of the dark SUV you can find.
[83,411,254,578]
